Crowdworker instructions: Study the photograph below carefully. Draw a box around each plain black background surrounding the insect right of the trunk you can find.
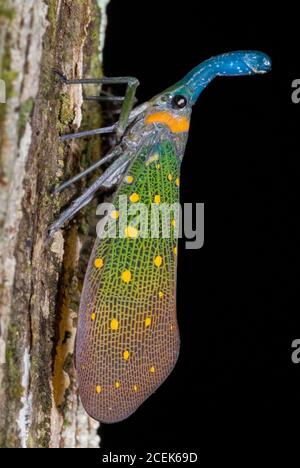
[100,0,300,449]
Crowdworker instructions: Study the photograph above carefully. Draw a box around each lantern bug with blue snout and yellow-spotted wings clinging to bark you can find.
[50,51,271,423]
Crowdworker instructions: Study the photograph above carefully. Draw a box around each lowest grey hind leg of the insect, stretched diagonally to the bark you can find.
[48,154,130,239]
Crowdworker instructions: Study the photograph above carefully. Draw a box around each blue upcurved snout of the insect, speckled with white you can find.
[177,50,271,104]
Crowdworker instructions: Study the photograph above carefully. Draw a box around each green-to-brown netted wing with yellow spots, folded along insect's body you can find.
[76,134,180,422]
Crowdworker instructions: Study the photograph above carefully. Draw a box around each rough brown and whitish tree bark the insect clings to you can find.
[0,0,107,447]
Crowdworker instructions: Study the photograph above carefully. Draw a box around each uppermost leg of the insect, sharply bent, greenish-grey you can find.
[54,70,139,140]
